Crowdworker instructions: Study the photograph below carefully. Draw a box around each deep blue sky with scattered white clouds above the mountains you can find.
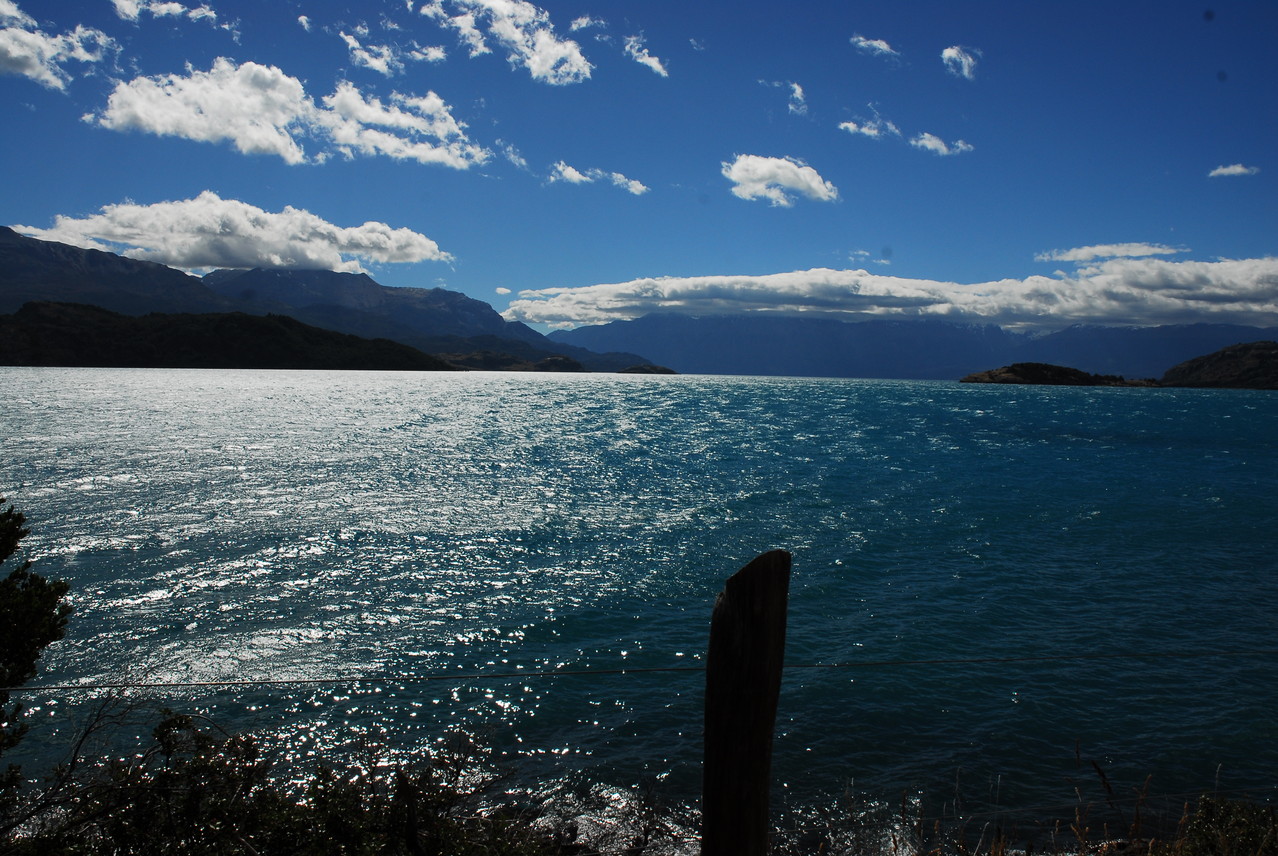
[0,0,1278,328]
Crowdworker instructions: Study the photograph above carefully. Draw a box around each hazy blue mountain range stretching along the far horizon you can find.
[0,226,1278,379]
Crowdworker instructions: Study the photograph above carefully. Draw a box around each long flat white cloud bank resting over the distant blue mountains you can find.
[504,258,1278,330]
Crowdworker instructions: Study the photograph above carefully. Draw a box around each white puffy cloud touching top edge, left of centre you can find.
[420,0,594,86]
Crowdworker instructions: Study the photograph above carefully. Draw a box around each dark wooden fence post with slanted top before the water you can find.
[702,549,790,856]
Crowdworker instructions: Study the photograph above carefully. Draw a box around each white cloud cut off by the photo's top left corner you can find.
[0,0,119,89]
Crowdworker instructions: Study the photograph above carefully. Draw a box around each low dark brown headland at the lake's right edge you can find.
[961,341,1278,390]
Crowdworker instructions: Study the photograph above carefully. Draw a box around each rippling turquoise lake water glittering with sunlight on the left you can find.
[0,368,1278,833]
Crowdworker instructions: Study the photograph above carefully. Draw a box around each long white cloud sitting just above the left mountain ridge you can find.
[14,190,452,273]
